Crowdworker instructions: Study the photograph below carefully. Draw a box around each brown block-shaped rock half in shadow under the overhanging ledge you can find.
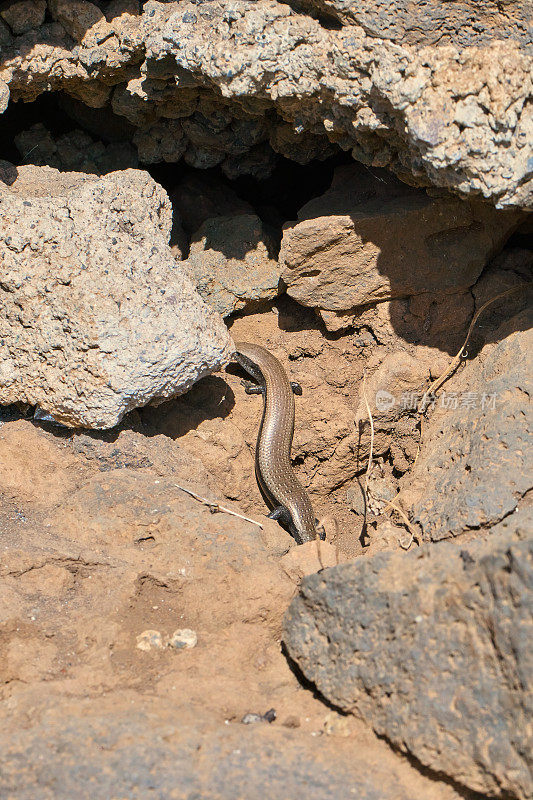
[280,165,520,312]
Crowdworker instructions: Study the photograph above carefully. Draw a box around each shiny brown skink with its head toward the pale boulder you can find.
[234,342,320,544]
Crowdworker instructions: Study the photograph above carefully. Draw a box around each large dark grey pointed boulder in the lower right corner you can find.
[284,524,533,798]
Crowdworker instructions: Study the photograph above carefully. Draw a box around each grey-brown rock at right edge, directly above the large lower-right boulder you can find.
[404,310,533,541]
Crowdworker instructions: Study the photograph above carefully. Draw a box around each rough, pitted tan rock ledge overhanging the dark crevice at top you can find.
[0,0,532,207]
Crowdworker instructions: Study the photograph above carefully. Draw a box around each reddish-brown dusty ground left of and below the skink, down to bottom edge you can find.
[0,416,459,800]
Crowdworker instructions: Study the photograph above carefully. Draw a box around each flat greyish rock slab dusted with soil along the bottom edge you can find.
[0,712,414,800]
